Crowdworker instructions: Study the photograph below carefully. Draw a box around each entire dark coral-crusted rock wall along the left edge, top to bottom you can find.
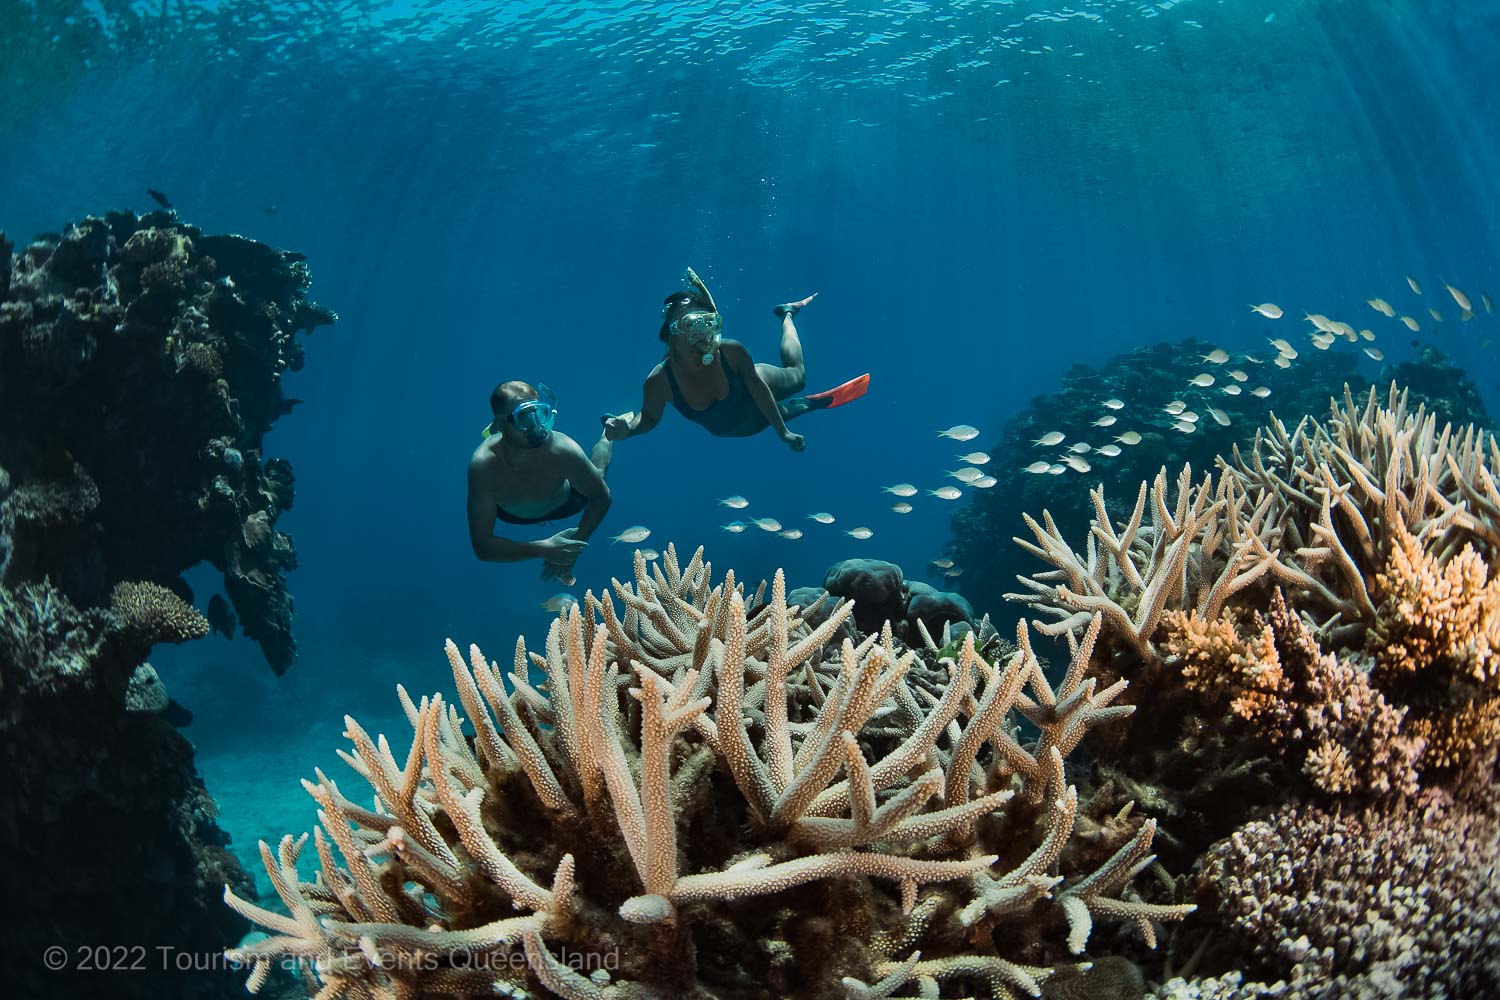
[0,211,335,997]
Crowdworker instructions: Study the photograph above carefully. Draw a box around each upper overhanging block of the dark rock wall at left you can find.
[0,211,336,673]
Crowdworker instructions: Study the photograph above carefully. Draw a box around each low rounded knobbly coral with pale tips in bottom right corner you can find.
[1194,792,1500,1000]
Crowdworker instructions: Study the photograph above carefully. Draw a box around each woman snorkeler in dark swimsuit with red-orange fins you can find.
[603,268,870,451]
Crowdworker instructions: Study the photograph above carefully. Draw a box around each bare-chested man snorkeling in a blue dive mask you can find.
[468,382,614,586]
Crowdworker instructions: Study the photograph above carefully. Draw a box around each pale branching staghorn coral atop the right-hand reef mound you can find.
[1007,385,1500,663]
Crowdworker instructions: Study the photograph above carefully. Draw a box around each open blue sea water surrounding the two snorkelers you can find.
[0,0,1500,881]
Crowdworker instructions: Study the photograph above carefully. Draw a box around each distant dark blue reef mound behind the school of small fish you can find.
[948,347,1490,612]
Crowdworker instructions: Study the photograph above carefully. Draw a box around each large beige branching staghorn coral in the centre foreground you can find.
[225,547,1193,999]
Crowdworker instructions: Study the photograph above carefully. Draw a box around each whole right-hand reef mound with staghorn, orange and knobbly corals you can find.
[1011,385,1500,999]
